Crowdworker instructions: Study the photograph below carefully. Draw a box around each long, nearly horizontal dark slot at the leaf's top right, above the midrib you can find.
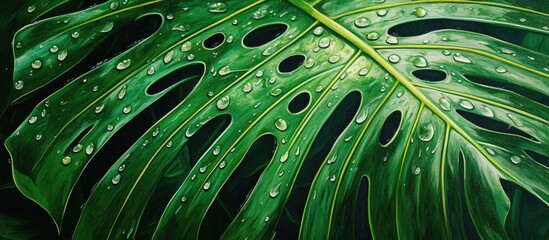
[388,18,549,51]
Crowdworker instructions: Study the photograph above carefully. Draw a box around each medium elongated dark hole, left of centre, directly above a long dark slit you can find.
[147,63,206,95]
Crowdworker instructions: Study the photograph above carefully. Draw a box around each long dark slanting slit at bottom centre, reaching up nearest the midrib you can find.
[276,91,362,239]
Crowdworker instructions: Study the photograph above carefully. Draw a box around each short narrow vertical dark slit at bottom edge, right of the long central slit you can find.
[354,176,373,239]
